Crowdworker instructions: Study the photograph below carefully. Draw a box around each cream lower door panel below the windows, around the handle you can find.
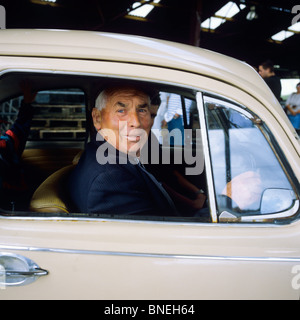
[0,220,300,299]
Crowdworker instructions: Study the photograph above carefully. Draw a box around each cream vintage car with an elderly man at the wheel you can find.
[0,30,300,300]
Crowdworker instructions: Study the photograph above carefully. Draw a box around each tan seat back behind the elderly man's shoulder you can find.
[29,164,75,213]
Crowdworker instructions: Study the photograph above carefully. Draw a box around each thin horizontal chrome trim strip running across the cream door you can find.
[0,245,300,263]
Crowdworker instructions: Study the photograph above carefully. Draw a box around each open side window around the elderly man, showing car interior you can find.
[0,74,211,222]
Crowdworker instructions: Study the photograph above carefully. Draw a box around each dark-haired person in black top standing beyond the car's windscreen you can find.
[258,60,282,102]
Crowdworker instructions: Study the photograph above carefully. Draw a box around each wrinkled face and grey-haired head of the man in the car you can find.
[92,88,152,156]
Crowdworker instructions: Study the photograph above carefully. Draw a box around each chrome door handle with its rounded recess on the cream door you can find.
[0,252,49,287]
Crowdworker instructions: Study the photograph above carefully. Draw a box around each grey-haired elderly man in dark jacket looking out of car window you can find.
[69,86,176,216]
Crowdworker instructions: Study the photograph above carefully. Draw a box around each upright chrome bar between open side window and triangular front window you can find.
[197,92,218,223]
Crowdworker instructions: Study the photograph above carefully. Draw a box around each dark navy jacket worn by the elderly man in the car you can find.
[68,137,175,216]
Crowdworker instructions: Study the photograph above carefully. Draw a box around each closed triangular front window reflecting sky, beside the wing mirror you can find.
[204,96,299,222]
